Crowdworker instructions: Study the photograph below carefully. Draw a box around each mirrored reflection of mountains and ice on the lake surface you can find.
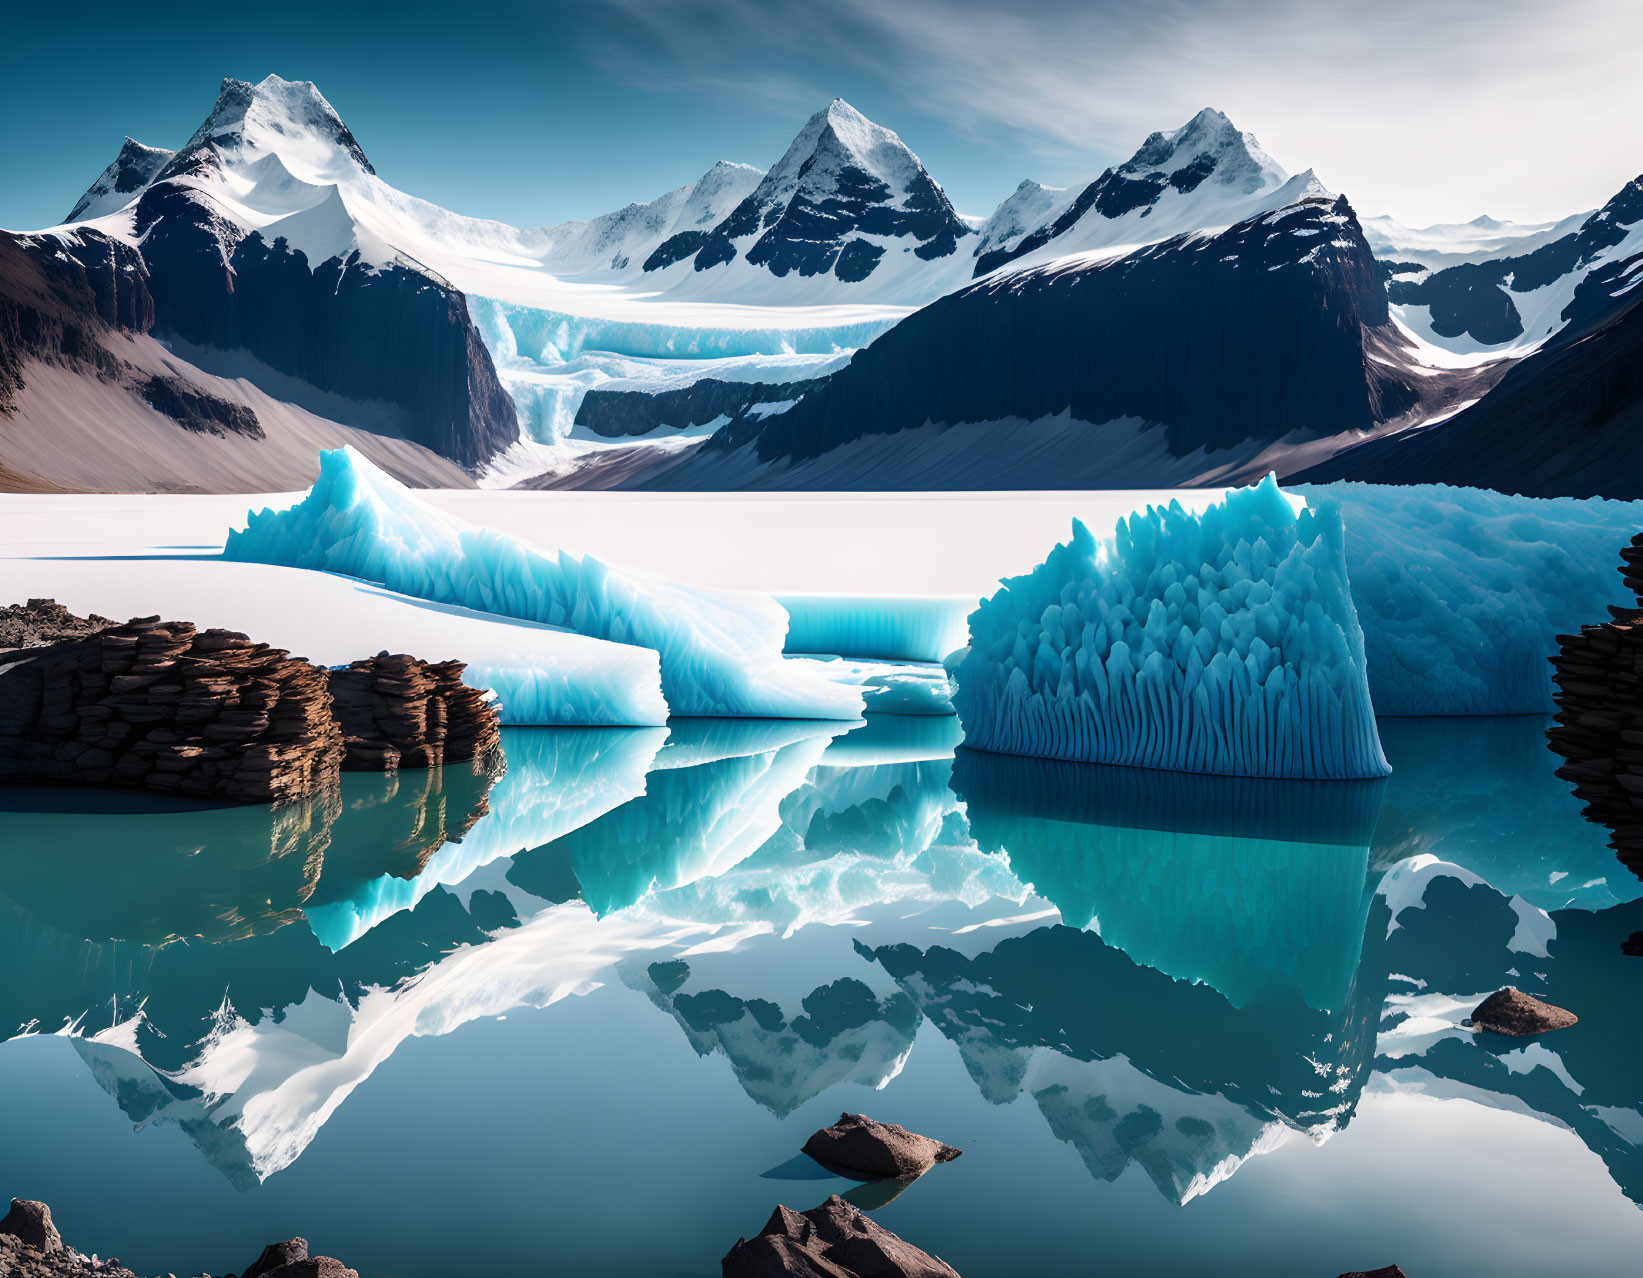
[0,718,1643,1268]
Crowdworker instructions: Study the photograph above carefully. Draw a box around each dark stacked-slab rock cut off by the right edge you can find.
[1546,532,1643,876]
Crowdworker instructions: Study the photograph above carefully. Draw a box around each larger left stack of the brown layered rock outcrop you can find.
[0,618,343,803]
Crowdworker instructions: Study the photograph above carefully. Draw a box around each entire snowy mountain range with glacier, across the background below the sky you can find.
[0,76,1643,488]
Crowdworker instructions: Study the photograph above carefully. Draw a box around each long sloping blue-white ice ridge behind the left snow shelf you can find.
[223,448,863,721]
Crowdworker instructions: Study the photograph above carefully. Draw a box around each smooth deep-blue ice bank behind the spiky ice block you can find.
[1293,483,1643,715]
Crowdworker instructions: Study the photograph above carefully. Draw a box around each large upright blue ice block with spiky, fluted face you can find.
[953,476,1390,779]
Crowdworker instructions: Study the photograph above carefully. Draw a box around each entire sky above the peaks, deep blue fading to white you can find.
[0,0,1643,228]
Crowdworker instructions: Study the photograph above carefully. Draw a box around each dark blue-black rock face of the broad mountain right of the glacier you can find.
[680,197,1452,486]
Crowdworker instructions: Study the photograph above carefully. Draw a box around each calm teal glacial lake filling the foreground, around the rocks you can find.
[0,718,1643,1278]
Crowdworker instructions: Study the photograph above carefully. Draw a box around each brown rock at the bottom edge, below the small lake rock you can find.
[723,1194,958,1278]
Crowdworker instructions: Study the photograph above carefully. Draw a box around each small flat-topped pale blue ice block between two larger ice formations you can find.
[777,595,969,662]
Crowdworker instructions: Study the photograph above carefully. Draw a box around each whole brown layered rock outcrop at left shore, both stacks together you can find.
[0,600,501,803]
